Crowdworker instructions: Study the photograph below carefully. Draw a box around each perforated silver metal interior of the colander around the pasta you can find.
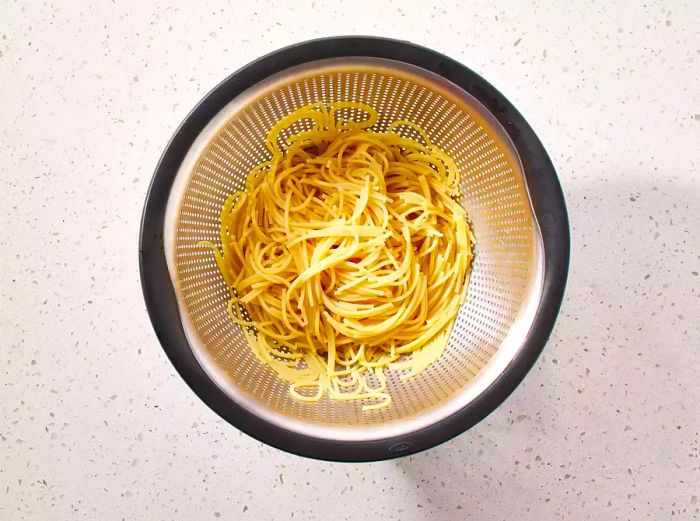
[165,58,543,439]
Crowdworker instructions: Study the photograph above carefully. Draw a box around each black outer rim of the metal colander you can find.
[139,36,570,462]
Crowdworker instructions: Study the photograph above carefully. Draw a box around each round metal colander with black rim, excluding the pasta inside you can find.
[140,37,569,461]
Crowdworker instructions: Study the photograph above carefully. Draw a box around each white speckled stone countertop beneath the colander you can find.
[0,0,700,521]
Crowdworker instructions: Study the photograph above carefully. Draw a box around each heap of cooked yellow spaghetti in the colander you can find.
[206,102,474,411]
